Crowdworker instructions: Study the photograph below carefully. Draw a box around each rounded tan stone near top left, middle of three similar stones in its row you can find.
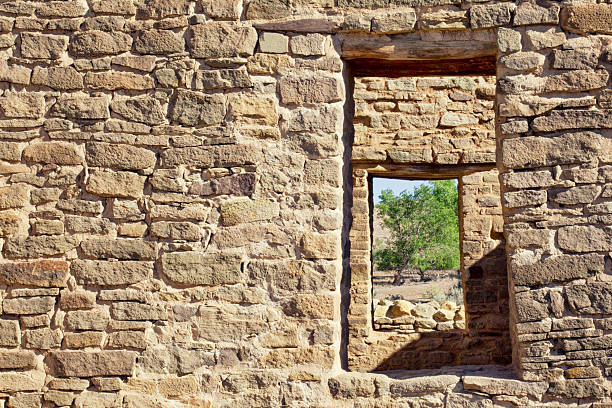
[70,30,132,56]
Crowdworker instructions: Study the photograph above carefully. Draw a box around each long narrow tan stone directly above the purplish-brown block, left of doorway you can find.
[162,145,263,168]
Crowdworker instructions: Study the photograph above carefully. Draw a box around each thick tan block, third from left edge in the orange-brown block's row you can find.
[162,252,244,286]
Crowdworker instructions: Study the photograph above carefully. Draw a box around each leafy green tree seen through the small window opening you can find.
[373,180,459,271]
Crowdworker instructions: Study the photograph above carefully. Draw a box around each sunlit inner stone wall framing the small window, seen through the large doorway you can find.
[348,77,511,371]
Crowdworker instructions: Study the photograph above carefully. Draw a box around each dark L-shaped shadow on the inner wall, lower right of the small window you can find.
[374,245,512,371]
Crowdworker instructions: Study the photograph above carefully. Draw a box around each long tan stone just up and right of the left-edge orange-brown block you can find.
[81,238,156,260]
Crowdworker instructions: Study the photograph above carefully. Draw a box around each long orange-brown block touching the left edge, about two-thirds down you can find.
[0,259,68,287]
